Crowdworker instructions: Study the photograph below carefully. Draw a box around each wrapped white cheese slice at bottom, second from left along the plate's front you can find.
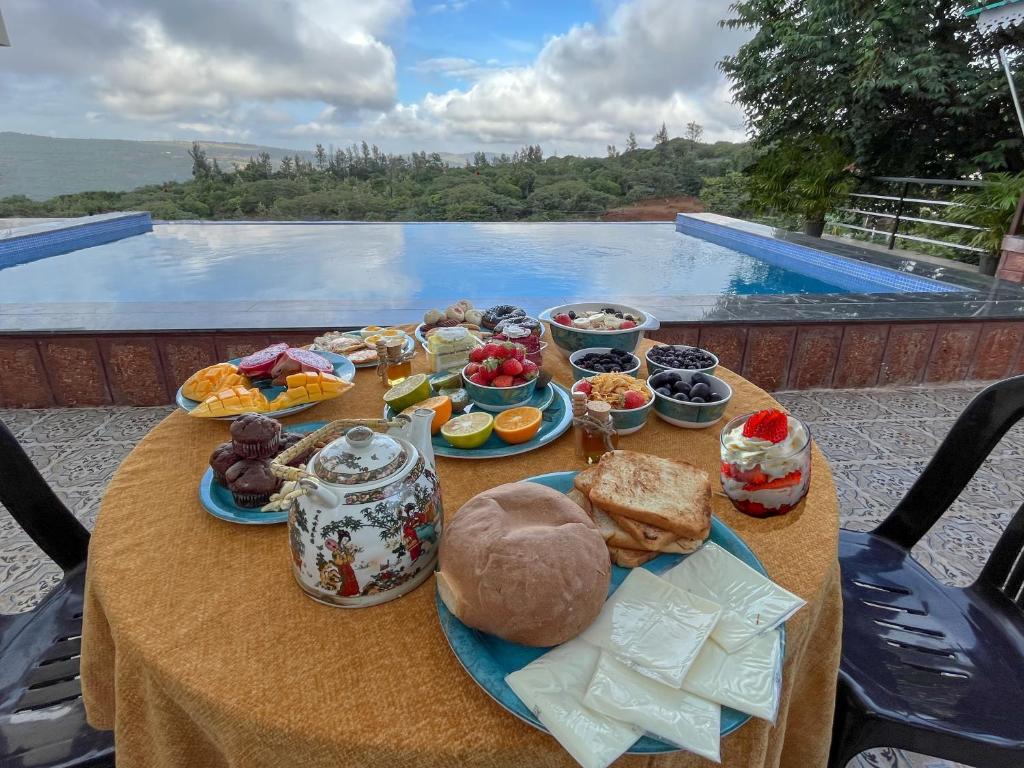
[583,653,722,763]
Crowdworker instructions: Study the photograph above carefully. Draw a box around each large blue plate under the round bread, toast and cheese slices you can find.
[434,472,785,755]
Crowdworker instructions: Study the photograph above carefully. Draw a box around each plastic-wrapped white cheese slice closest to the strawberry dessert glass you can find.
[662,542,805,653]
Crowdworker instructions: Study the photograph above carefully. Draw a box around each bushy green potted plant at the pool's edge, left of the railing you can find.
[749,135,856,238]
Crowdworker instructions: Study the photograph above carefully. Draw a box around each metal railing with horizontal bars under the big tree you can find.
[828,176,988,254]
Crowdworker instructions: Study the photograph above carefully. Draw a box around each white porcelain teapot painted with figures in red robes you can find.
[270,409,443,608]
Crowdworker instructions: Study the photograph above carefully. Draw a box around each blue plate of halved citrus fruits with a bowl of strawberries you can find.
[384,352,572,459]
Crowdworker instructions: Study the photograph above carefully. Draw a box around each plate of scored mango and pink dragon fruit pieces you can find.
[175,343,355,421]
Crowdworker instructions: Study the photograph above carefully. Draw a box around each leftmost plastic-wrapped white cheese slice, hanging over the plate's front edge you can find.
[505,639,643,768]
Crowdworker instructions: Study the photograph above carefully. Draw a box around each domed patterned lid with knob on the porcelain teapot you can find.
[312,426,409,485]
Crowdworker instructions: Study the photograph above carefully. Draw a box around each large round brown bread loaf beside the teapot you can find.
[437,482,611,647]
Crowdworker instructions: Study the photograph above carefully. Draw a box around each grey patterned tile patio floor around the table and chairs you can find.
[0,385,1024,768]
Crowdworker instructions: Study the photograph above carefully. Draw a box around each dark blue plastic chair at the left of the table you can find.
[0,422,114,768]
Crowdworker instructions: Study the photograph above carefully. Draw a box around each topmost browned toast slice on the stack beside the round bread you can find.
[589,451,711,541]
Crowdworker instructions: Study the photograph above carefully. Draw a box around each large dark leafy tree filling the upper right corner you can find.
[720,0,1024,176]
